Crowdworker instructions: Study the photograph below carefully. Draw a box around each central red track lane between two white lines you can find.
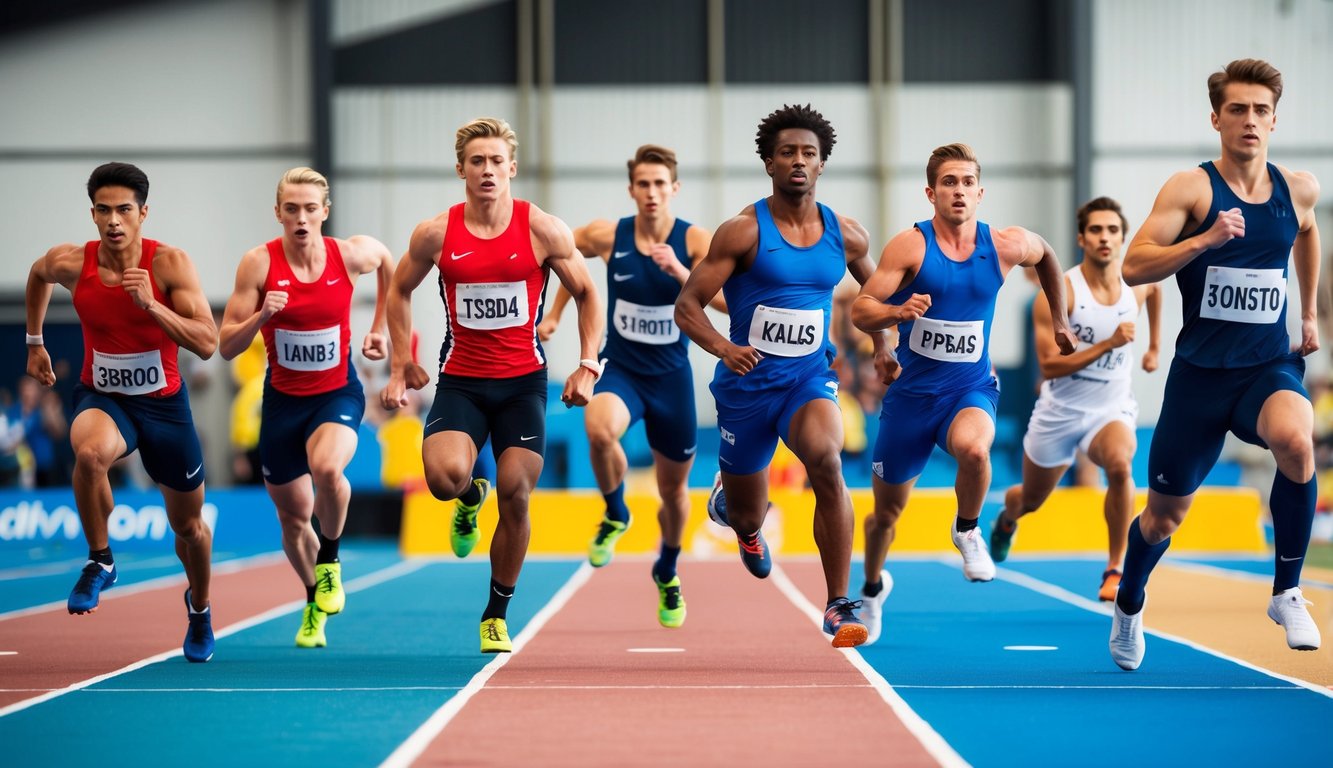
[417,561,936,767]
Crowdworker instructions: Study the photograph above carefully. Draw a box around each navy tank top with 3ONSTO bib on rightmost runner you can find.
[1176,161,1300,368]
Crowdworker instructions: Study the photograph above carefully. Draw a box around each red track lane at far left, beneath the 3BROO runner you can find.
[0,561,301,707]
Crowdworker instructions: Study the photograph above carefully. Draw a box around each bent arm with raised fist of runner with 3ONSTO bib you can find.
[1121,168,1245,285]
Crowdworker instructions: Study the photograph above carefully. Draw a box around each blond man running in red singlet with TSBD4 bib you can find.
[380,117,603,653]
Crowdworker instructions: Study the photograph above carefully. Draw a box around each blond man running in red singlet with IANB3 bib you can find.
[221,168,393,648]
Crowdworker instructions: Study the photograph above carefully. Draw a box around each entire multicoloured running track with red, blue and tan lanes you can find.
[0,545,1333,768]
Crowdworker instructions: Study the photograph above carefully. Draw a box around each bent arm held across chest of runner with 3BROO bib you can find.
[141,245,217,360]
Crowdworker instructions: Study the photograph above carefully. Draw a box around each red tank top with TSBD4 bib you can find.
[439,200,549,379]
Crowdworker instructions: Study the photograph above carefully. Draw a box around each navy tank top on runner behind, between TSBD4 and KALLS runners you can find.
[603,216,690,375]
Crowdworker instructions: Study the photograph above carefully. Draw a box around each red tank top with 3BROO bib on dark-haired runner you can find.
[73,239,180,397]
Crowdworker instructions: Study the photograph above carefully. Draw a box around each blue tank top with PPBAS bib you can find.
[888,221,1004,396]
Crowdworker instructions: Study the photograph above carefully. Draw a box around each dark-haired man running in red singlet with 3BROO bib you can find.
[25,163,217,661]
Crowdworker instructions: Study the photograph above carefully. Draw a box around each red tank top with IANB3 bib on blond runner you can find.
[256,237,352,395]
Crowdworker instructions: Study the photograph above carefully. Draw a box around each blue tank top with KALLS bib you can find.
[713,199,846,391]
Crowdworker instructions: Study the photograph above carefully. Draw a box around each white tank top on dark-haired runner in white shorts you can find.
[1041,267,1138,409]
